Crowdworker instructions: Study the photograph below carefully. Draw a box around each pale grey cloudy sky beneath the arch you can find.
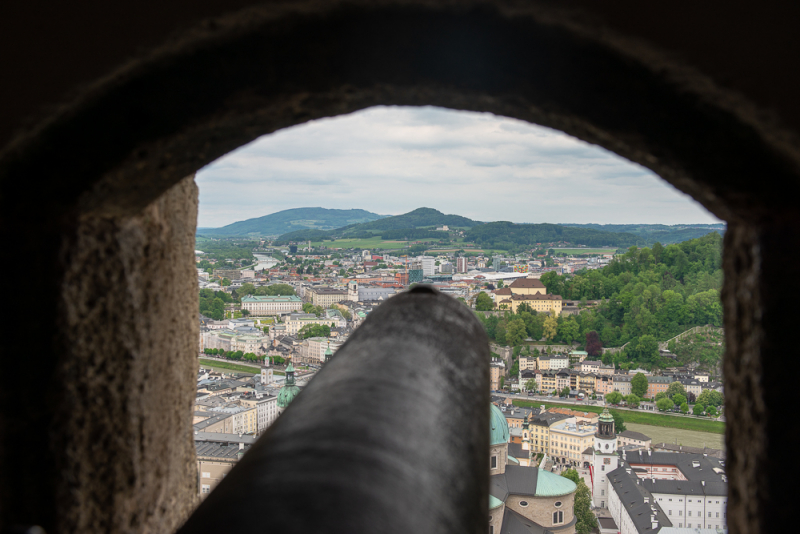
[197,107,718,227]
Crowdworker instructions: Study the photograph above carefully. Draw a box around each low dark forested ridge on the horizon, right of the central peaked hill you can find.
[465,221,645,250]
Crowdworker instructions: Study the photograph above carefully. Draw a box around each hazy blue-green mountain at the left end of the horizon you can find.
[197,208,386,236]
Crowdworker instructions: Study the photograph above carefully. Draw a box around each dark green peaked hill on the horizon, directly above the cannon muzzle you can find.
[275,208,483,244]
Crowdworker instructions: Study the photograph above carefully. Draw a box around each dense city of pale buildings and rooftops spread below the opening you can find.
[194,247,727,534]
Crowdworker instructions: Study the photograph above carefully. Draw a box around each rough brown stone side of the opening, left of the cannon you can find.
[51,177,199,532]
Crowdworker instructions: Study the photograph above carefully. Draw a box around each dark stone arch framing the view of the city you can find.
[0,1,800,532]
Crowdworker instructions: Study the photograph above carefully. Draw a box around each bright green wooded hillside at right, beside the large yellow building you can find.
[479,233,722,372]
